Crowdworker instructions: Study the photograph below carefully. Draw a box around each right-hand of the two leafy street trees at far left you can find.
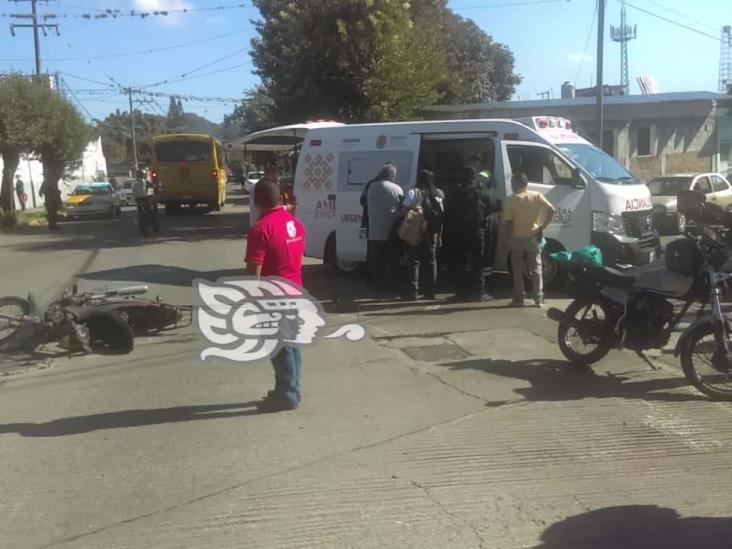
[34,92,91,199]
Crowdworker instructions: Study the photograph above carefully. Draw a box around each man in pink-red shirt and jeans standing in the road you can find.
[246,179,305,412]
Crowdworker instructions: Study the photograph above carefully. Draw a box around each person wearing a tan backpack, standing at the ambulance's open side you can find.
[399,170,445,301]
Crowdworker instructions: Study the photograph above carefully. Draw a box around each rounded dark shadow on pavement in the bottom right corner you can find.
[533,505,732,549]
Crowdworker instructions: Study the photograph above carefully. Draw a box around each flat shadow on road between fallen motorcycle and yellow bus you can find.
[79,265,244,287]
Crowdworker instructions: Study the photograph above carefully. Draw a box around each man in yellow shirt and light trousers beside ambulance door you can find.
[503,172,555,307]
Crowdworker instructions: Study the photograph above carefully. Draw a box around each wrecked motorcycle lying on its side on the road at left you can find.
[0,286,191,354]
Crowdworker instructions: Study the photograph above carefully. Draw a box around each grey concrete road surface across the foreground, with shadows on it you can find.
[0,191,732,548]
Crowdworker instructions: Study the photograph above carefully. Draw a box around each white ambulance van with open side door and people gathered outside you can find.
[239,117,660,282]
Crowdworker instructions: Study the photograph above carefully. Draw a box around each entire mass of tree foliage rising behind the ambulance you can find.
[246,0,520,125]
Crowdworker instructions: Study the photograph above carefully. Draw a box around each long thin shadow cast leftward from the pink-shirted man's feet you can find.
[0,401,260,437]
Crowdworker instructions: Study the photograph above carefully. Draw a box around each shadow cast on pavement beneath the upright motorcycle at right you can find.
[441,359,709,402]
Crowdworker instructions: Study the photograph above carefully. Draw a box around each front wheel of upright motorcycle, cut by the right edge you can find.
[681,322,732,400]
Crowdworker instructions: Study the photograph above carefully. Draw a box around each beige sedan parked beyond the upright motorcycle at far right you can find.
[648,173,732,233]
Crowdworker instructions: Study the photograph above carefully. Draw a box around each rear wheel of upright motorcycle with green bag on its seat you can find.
[557,299,613,366]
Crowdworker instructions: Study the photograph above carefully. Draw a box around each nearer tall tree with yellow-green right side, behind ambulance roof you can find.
[252,0,446,123]
